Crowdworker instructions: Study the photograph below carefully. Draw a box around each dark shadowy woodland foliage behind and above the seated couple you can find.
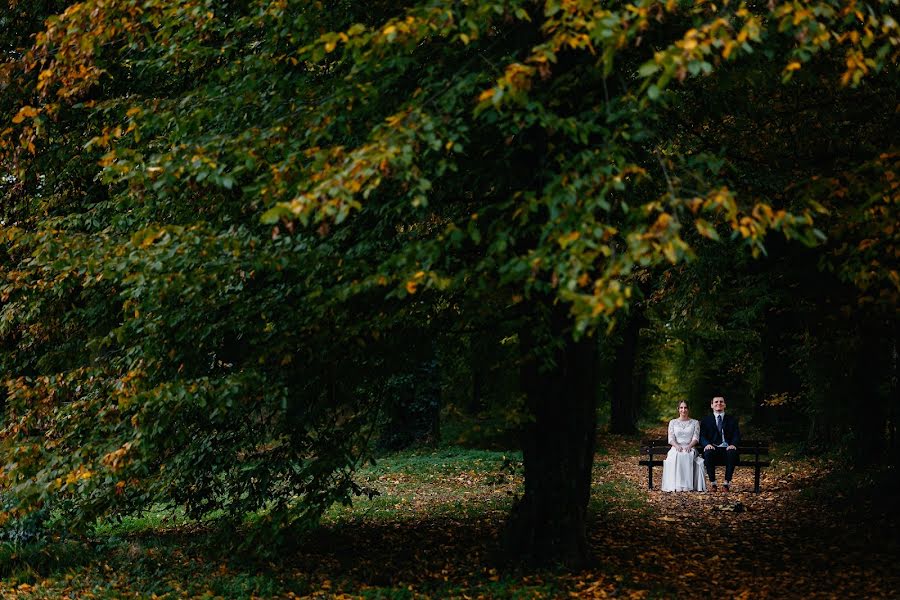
[628,4,900,428]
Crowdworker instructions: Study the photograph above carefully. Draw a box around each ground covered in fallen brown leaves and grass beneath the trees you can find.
[0,435,900,599]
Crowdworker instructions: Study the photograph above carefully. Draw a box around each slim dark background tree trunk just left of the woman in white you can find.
[609,305,645,434]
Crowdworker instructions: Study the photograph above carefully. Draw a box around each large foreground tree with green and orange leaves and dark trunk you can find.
[0,0,898,565]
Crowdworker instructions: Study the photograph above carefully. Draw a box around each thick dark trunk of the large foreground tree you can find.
[505,318,597,568]
